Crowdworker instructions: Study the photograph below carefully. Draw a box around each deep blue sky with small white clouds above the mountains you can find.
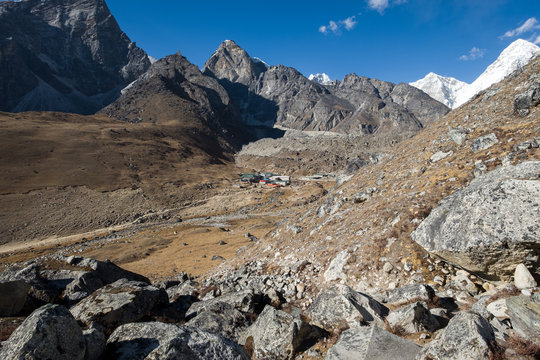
[107,0,540,82]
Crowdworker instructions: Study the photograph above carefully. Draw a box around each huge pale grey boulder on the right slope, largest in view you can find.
[411,161,540,279]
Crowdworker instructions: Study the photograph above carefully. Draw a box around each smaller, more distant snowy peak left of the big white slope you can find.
[409,72,469,109]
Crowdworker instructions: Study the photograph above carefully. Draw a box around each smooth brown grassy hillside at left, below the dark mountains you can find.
[0,112,234,243]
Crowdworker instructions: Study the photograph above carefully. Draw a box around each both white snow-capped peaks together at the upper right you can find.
[410,39,540,109]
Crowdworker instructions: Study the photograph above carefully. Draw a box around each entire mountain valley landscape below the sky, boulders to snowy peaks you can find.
[0,0,540,360]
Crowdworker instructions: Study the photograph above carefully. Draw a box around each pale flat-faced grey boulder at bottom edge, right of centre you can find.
[325,326,421,360]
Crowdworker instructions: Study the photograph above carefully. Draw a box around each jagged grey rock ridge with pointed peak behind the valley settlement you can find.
[204,40,448,134]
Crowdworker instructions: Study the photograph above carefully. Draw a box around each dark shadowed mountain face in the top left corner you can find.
[0,0,150,114]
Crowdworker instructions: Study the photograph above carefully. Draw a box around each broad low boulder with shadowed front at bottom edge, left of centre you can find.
[105,322,249,360]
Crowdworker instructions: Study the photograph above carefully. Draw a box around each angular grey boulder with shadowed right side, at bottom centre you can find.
[241,306,321,359]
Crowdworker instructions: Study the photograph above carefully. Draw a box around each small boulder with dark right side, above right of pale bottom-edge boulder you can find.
[386,301,439,333]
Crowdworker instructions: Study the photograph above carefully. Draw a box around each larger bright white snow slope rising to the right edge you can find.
[456,39,540,107]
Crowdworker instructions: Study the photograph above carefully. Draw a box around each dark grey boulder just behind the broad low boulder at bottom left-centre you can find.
[186,302,251,341]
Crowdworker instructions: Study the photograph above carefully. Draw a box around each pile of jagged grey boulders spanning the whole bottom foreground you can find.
[0,257,540,360]
